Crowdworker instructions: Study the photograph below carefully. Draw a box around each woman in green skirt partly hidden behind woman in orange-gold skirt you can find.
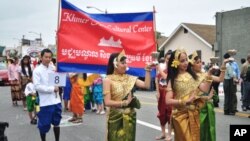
[189,52,228,141]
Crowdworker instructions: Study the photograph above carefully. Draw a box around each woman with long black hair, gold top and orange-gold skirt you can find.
[166,49,212,141]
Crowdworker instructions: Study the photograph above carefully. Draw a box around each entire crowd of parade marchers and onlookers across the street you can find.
[4,49,250,141]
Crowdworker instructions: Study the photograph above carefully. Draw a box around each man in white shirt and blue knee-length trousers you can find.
[33,49,62,141]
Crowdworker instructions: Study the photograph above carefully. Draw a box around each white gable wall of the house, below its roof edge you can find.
[164,28,215,63]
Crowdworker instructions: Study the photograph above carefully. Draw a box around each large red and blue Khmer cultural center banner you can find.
[57,0,156,76]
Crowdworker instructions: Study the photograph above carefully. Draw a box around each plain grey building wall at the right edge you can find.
[215,7,250,63]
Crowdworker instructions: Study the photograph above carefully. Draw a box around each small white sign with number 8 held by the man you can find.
[49,73,66,87]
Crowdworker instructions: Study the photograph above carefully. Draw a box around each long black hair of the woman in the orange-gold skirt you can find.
[167,50,198,90]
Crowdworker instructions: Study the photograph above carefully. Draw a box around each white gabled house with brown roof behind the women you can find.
[160,23,215,63]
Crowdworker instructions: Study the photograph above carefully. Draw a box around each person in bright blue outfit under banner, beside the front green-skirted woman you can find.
[92,76,105,115]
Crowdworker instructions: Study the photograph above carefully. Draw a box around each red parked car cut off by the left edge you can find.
[0,63,10,86]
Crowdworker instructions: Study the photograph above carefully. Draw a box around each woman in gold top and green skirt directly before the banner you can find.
[103,51,151,141]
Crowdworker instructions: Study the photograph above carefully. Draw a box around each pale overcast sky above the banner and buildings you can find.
[0,0,250,47]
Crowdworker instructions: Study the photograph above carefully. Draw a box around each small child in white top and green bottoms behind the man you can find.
[24,79,37,125]
